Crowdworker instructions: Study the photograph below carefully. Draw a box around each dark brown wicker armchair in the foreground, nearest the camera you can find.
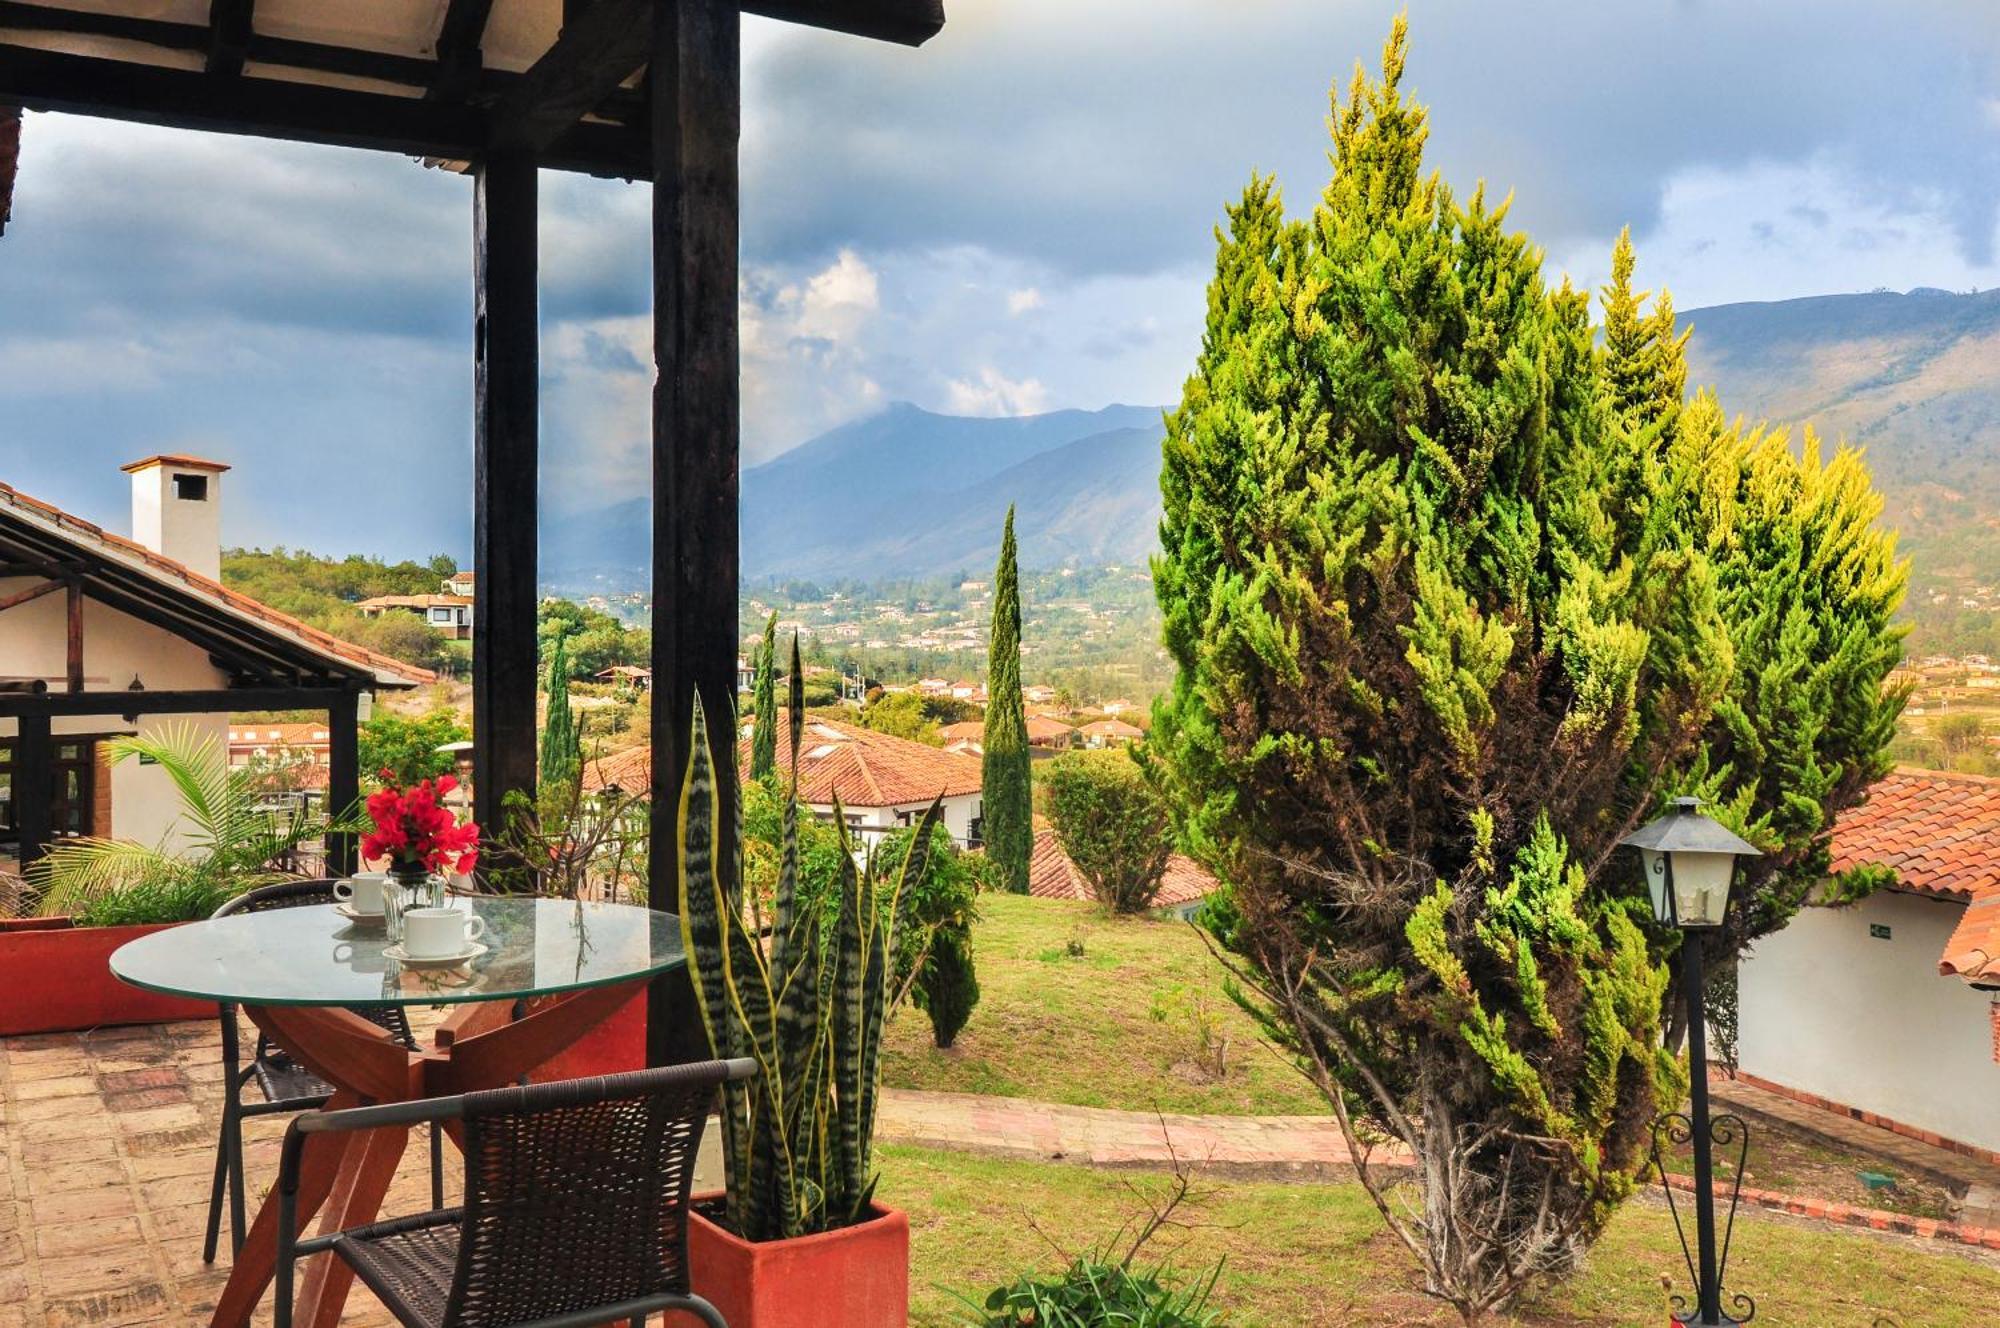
[274,1060,756,1328]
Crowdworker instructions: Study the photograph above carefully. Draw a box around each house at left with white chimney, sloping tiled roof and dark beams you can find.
[0,454,432,870]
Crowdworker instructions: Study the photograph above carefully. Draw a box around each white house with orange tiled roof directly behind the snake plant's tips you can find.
[584,718,982,848]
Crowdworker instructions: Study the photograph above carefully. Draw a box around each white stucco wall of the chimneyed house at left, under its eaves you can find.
[0,576,228,844]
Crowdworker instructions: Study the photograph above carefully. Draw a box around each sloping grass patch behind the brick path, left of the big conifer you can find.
[882,894,1326,1116]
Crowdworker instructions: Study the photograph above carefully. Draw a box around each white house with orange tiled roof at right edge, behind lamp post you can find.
[1736,768,2000,1156]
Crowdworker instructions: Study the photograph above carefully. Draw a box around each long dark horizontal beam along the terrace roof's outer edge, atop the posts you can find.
[0,45,646,178]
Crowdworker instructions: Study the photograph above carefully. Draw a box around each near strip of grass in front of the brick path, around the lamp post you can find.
[892,1148,2000,1328]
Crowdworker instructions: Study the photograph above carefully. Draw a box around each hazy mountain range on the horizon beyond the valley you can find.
[542,290,2000,604]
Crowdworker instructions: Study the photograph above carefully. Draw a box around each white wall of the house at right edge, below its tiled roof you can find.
[1738,894,2000,1148]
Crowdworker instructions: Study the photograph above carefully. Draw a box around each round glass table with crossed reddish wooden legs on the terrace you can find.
[110,896,684,1328]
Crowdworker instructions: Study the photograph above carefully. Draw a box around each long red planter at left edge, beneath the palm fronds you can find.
[0,918,216,1036]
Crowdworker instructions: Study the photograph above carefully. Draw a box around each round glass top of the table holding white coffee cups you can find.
[110,896,684,1006]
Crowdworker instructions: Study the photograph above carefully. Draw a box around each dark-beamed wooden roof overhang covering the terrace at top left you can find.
[0,0,944,178]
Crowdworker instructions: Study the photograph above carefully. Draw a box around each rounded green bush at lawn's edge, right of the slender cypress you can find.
[1038,750,1174,912]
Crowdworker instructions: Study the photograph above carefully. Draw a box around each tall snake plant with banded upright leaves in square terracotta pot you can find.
[680,640,940,1240]
